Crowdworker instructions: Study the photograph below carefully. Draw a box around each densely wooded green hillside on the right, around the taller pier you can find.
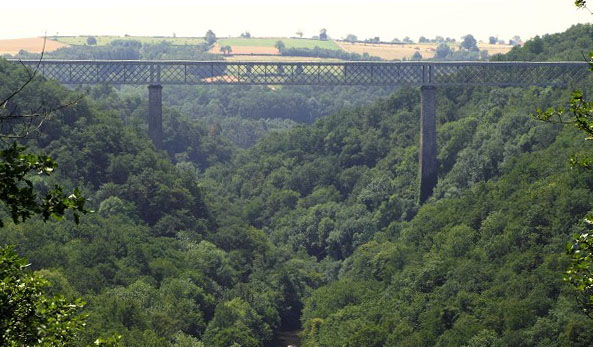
[198,23,593,346]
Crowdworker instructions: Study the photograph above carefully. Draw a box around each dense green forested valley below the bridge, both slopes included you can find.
[0,25,593,347]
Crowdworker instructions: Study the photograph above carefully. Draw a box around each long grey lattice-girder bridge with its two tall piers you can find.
[13,60,589,203]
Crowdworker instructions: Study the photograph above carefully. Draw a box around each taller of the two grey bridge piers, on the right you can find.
[419,86,438,204]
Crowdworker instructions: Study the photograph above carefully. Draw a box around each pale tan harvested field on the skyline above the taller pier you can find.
[336,41,512,60]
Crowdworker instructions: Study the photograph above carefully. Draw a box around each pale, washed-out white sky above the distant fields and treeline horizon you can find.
[0,0,593,41]
